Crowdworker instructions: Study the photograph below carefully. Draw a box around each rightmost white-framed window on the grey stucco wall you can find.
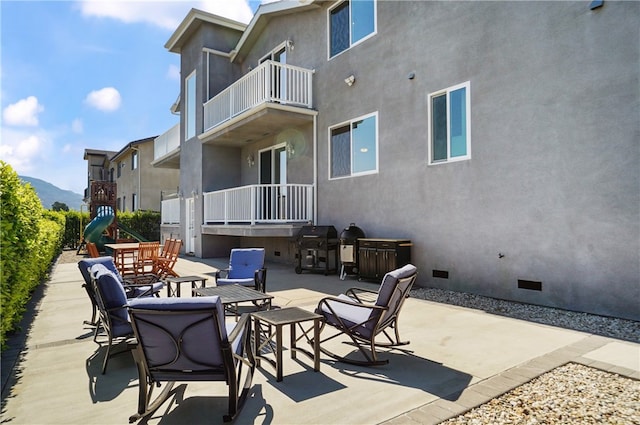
[429,81,471,164]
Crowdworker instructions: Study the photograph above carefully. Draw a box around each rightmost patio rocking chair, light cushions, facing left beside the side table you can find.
[316,264,417,366]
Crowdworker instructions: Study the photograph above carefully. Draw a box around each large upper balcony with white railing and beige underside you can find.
[200,60,316,146]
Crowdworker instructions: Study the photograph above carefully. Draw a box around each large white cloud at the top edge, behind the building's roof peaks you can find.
[80,0,253,31]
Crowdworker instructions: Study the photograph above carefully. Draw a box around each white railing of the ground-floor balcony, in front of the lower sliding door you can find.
[204,184,313,224]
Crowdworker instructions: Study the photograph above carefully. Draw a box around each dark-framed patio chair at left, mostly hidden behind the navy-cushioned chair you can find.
[78,256,164,326]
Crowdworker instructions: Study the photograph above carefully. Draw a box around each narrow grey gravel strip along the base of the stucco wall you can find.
[411,288,640,343]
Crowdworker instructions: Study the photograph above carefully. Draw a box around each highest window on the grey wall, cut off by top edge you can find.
[329,0,377,58]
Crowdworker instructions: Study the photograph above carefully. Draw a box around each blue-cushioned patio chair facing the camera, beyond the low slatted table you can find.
[216,248,267,292]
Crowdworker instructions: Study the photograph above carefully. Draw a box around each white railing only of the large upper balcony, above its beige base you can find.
[204,61,313,132]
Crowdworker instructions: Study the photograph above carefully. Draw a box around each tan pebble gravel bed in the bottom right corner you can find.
[442,363,640,425]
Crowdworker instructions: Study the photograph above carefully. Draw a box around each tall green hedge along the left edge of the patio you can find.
[0,161,65,347]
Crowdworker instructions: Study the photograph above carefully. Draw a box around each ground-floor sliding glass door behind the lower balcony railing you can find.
[259,144,287,221]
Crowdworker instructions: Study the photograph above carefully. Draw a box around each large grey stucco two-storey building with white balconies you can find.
[160,0,640,320]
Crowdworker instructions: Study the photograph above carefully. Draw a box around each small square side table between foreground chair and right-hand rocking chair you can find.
[251,307,322,382]
